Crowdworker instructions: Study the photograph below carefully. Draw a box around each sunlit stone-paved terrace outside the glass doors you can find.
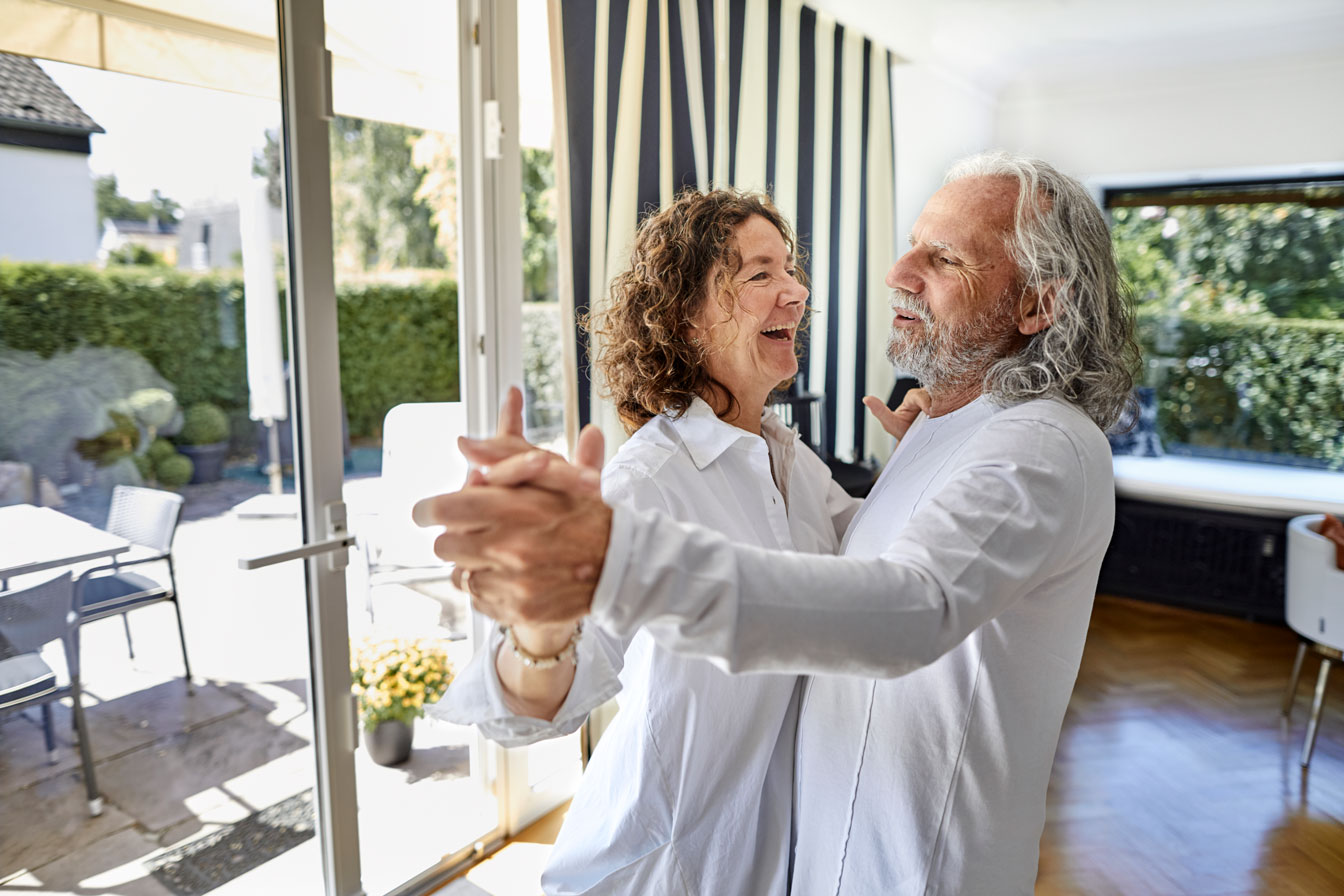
[0,477,505,896]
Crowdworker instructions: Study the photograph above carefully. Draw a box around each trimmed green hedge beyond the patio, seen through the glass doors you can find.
[0,262,458,437]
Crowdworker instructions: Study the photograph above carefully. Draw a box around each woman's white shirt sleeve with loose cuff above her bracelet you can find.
[426,466,667,747]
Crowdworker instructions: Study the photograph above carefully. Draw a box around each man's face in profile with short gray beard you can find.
[886,177,1021,390]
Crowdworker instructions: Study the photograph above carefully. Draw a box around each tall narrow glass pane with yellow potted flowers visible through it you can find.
[318,1,499,893]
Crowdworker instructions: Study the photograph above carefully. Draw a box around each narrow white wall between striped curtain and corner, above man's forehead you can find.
[891,63,995,245]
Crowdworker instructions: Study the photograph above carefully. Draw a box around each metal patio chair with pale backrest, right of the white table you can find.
[75,485,191,690]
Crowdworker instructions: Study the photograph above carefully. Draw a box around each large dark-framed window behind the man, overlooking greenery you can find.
[1105,176,1344,469]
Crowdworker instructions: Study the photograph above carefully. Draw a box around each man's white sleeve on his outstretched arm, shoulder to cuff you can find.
[593,419,1114,677]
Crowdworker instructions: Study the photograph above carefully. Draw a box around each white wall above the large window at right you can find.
[993,55,1344,181]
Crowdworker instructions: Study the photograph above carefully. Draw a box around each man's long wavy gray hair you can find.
[945,152,1141,430]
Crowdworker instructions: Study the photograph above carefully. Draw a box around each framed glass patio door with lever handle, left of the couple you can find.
[280,0,579,895]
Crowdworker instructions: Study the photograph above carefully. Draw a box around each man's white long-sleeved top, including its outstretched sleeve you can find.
[593,398,1114,896]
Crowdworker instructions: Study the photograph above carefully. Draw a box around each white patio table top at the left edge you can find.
[0,504,130,579]
